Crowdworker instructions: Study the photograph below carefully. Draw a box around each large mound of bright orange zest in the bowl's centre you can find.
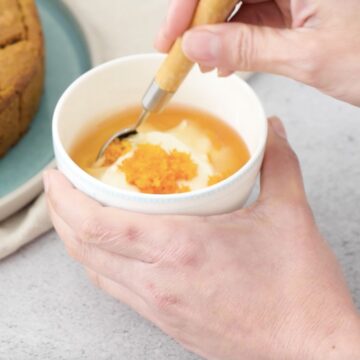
[119,144,198,194]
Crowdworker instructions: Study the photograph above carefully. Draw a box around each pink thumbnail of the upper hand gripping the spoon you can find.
[183,30,221,66]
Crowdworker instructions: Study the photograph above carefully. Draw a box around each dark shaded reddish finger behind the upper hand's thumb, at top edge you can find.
[232,1,290,28]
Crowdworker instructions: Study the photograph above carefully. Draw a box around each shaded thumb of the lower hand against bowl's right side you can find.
[260,118,306,202]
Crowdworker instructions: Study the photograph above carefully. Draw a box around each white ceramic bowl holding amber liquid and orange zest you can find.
[53,54,267,215]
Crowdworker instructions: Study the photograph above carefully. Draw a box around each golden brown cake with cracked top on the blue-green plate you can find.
[0,0,44,157]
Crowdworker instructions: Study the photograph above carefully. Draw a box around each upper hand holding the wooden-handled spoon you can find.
[156,0,360,106]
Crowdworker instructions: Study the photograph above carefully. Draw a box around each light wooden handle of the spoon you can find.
[155,0,239,93]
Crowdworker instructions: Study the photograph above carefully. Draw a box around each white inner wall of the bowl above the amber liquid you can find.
[56,54,266,155]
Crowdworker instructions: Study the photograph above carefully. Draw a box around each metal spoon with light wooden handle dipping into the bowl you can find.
[98,0,239,159]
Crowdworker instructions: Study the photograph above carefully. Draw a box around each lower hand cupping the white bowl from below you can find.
[44,119,360,360]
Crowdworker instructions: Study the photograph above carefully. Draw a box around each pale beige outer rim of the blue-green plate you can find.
[0,0,94,223]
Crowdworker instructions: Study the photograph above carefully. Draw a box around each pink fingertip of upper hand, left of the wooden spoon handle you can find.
[155,0,199,52]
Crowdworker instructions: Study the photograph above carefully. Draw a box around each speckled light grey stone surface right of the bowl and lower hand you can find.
[250,75,360,309]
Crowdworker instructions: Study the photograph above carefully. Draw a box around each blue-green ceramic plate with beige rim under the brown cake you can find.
[0,0,91,220]
